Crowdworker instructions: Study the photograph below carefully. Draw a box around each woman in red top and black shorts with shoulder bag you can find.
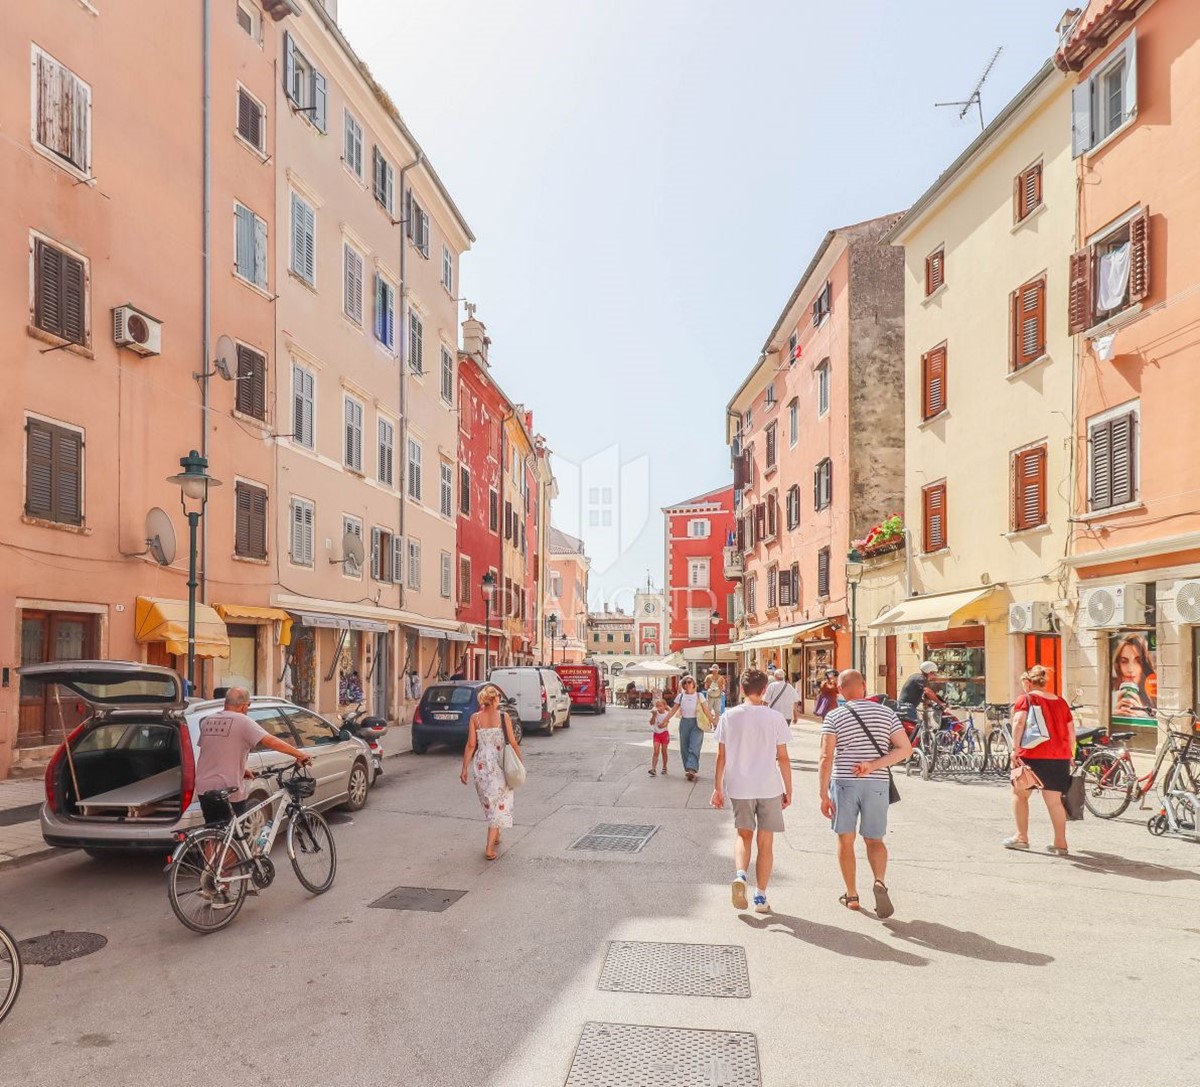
[1004,665,1075,857]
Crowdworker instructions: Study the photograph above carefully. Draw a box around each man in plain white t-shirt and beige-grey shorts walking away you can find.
[712,668,792,913]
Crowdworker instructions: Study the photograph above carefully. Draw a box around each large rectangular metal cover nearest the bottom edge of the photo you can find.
[565,1022,762,1087]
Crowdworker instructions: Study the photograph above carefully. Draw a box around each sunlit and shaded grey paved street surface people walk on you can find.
[0,710,1200,1087]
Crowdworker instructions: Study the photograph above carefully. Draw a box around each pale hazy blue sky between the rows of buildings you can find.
[338,0,1068,609]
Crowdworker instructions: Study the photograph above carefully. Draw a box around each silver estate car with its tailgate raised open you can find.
[20,661,371,855]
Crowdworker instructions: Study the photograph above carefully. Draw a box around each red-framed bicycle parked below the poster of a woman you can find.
[1080,707,1200,819]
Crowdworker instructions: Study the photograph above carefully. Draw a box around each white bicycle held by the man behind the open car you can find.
[167,765,337,933]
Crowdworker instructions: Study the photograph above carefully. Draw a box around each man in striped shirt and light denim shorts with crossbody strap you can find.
[818,669,912,918]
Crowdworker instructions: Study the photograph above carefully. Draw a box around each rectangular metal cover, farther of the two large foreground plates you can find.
[599,942,750,997]
